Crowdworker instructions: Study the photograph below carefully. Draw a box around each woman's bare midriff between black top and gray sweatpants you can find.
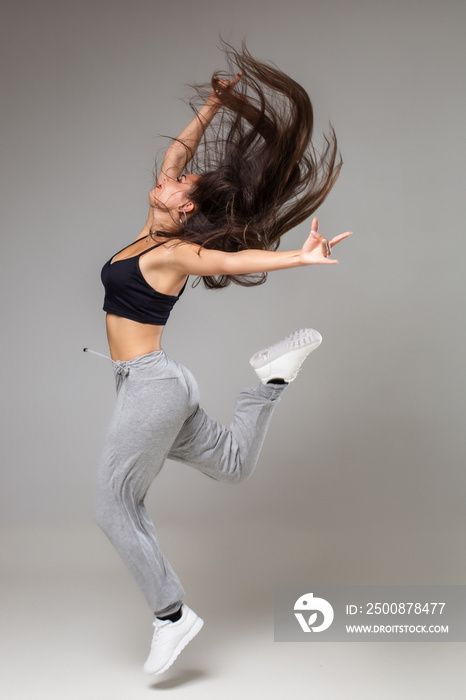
[106,314,165,361]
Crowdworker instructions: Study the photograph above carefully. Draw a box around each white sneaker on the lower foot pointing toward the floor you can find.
[144,605,204,673]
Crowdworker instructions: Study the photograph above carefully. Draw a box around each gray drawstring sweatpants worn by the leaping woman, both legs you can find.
[95,350,286,615]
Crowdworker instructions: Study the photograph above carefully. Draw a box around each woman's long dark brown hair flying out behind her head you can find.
[165,44,342,289]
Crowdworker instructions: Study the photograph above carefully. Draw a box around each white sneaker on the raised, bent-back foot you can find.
[249,328,322,384]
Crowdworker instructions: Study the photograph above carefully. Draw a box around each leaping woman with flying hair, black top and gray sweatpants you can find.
[88,47,350,673]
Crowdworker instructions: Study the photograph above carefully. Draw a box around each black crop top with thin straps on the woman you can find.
[101,241,186,326]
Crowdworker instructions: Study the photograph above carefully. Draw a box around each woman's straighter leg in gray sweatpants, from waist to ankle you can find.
[95,351,193,615]
